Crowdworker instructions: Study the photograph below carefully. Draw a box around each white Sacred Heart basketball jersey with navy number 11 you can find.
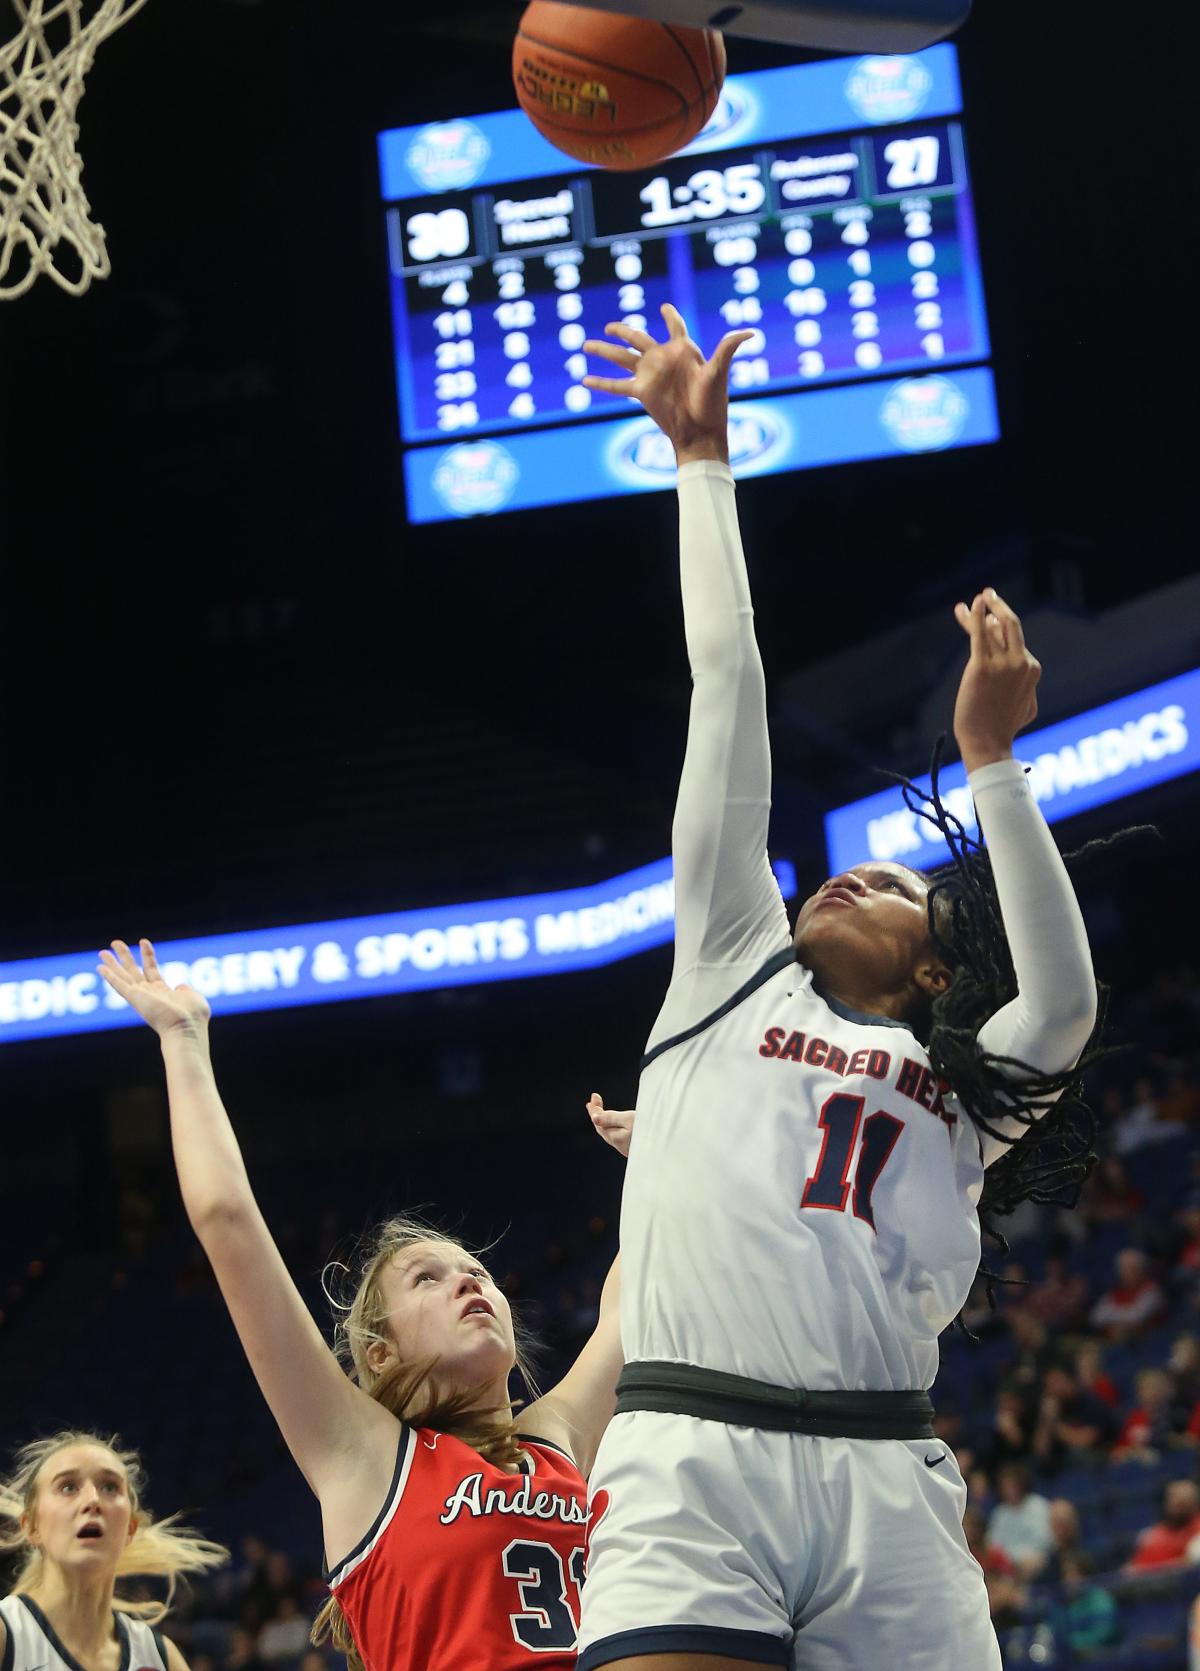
[620,949,983,1390]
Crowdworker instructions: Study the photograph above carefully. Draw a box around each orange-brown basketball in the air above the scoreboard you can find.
[513,0,725,169]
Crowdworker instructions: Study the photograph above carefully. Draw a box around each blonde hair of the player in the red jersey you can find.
[313,1216,536,1671]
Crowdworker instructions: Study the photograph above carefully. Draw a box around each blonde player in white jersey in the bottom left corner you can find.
[0,1432,227,1671]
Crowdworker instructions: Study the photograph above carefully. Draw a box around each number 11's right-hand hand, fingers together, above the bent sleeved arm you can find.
[954,587,1041,772]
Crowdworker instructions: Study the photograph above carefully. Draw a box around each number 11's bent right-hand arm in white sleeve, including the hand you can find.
[954,588,1096,1163]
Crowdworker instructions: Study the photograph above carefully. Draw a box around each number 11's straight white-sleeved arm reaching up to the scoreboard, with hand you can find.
[583,306,789,1009]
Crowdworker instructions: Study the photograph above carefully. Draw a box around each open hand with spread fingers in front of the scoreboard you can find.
[583,302,754,465]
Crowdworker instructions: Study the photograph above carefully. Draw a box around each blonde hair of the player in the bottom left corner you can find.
[0,1430,229,1624]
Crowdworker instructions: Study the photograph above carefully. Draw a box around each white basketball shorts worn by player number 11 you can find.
[578,1410,1001,1671]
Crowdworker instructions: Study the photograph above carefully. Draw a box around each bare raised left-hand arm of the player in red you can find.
[100,939,399,1549]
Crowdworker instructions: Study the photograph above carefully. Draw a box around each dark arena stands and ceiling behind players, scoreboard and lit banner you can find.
[0,0,1200,1671]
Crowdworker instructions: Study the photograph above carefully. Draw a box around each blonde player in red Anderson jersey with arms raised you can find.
[100,941,622,1671]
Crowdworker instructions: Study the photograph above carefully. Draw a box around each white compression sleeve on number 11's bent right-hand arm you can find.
[968,760,1096,1163]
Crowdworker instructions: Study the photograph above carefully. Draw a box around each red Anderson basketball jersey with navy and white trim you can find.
[329,1427,601,1671]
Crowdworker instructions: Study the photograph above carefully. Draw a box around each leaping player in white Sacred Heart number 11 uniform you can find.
[578,307,1096,1671]
